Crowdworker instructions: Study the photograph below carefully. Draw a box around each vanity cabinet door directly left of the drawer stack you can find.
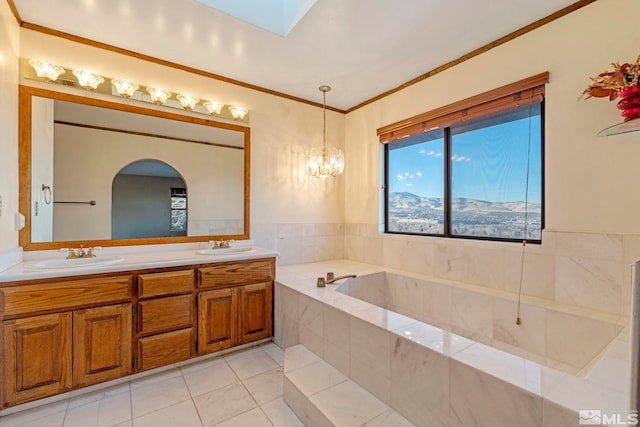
[73,304,131,387]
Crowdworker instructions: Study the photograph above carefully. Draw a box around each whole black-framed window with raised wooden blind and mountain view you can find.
[378,73,546,242]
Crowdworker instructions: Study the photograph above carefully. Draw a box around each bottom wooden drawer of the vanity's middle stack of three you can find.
[137,328,195,371]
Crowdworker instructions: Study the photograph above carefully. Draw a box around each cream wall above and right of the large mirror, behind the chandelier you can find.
[20,29,344,263]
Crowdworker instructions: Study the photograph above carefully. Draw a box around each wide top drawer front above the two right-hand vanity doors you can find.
[198,259,275,288]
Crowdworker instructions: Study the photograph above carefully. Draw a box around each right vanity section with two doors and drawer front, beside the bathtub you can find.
[198,259,275,354]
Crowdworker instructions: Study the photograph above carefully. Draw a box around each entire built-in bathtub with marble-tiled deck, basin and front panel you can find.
[274,260,629,427]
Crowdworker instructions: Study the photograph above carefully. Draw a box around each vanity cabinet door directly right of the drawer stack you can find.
[198,289,238,354]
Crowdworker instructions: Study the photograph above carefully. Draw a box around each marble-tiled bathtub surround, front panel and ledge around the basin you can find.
[275,260,629,427]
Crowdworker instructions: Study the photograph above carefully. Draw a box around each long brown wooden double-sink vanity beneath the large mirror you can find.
[0,250,276,408]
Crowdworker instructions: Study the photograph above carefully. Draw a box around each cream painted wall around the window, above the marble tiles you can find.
[346,0,640,233]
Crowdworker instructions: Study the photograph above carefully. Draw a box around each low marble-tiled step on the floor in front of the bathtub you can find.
[283,344,414,427]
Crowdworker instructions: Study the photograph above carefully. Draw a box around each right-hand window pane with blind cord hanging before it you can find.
[451,104,542,240]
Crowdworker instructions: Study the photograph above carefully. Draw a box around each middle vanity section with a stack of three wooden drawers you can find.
[135,269,196,371]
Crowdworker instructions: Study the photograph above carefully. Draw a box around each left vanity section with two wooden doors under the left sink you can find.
[0,275,132,406]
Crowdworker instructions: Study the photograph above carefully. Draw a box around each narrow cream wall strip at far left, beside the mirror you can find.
[0,1,20,252]
